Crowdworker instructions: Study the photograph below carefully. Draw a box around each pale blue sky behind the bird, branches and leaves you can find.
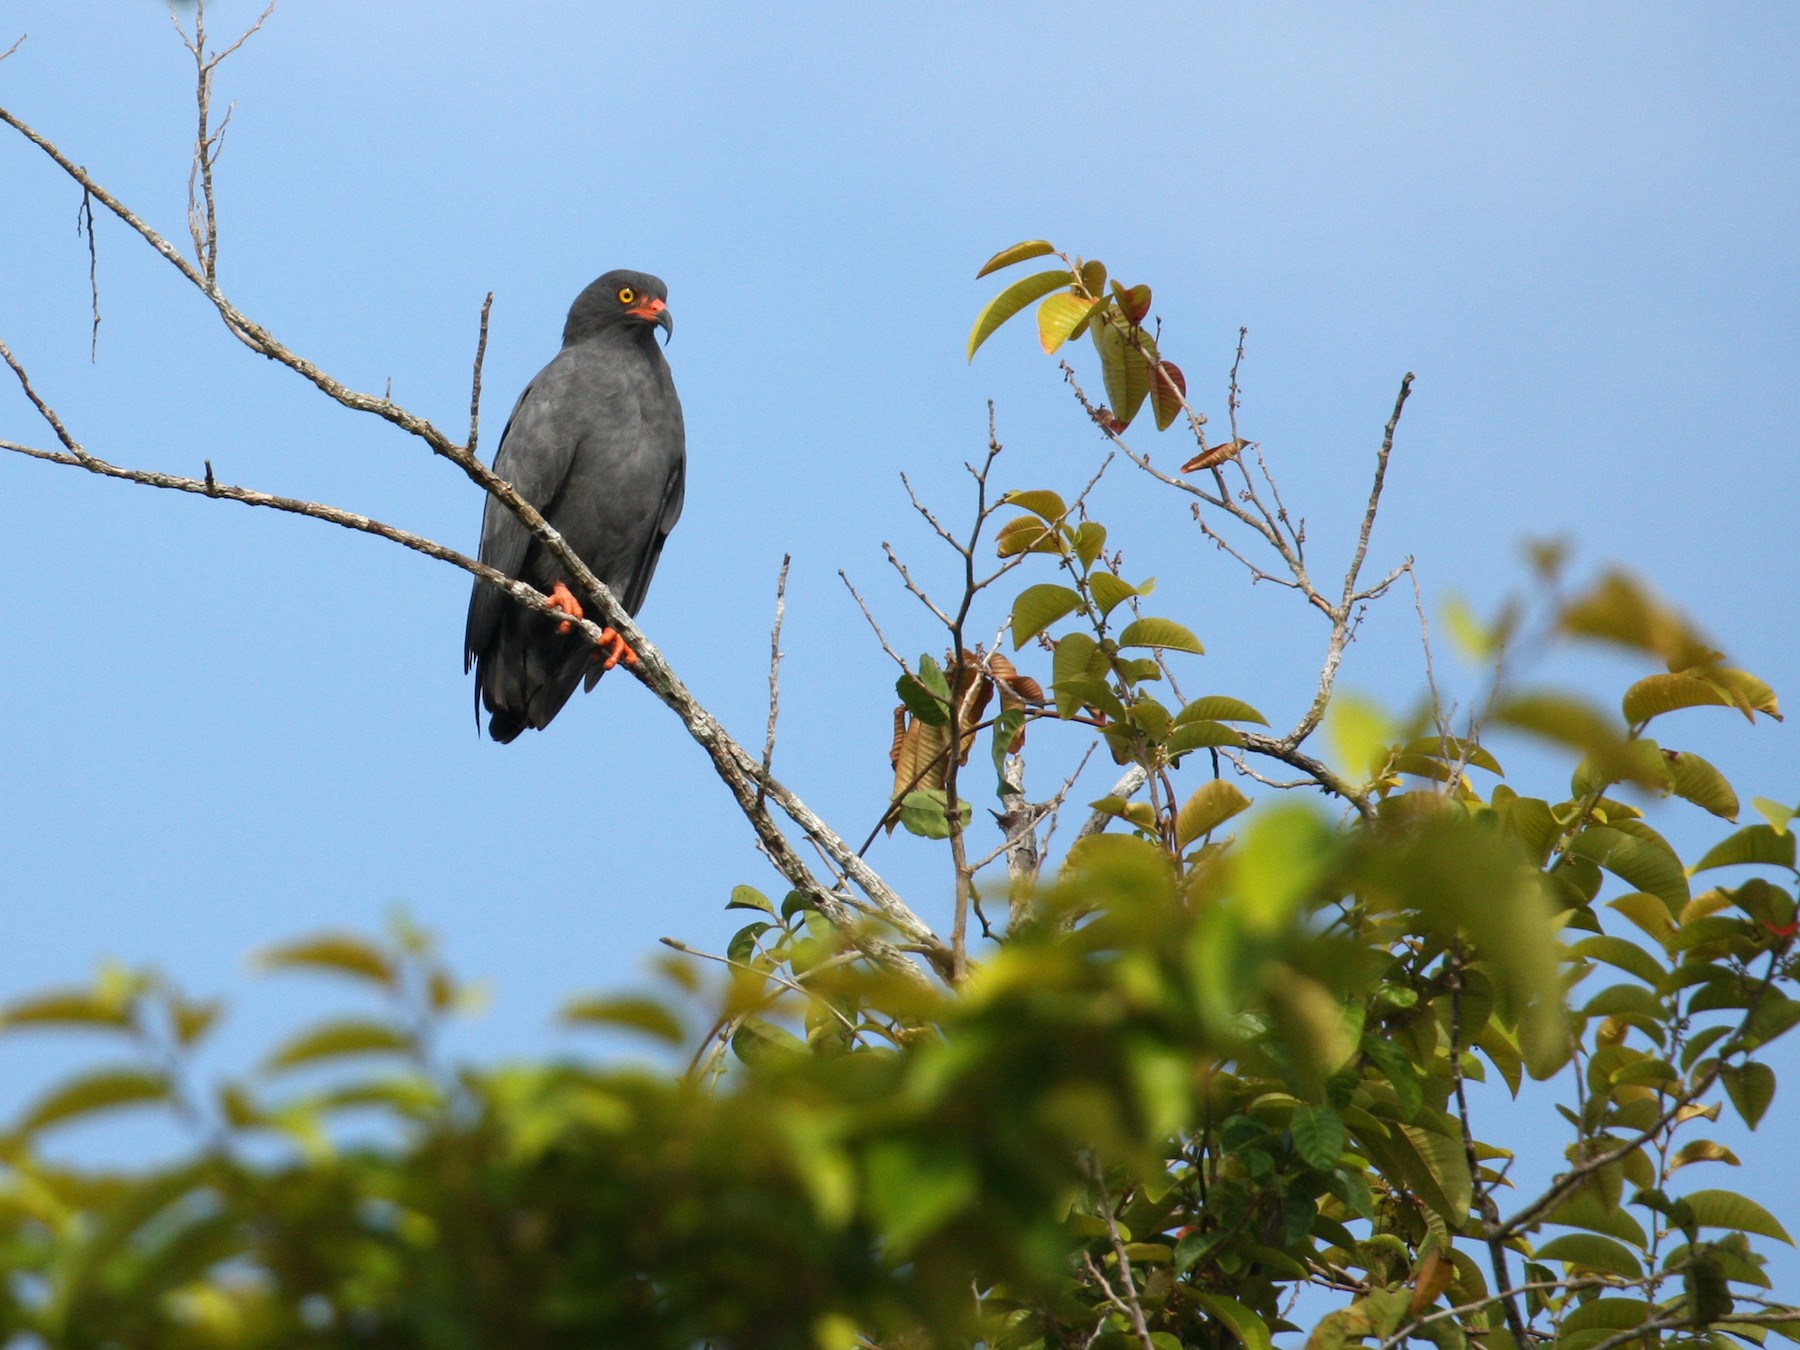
[0,0,1800,1292]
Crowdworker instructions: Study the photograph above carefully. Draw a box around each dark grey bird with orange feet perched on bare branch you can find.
[463,272,688,742]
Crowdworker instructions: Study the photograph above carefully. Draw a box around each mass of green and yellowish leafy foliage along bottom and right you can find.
[0,241,1800,1350]
